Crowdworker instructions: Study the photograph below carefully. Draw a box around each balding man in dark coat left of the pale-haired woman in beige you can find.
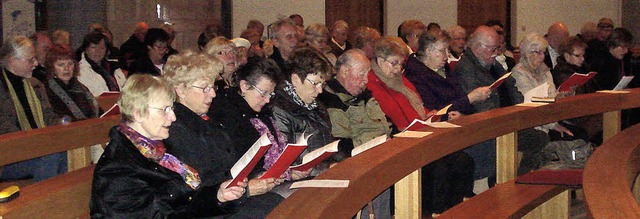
[455,26,549,181]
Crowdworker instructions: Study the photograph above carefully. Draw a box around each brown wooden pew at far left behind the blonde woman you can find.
[0,116,120,219]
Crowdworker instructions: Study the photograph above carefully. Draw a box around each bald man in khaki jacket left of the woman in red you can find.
[318,49,391,218]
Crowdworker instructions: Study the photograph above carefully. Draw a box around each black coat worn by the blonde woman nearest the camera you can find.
[89,126,235,218]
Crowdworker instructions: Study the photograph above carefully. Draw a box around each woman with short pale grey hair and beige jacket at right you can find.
[511,33,573,140]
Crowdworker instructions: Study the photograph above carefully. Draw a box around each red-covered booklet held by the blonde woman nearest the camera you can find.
[227,134,271,188]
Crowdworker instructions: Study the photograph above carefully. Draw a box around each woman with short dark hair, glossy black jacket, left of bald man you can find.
[273,47,344,186]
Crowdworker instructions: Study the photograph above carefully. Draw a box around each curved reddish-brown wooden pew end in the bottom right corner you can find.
[583,124,640,218]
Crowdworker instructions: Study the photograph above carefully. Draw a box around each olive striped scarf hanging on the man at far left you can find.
[2,69,46,131]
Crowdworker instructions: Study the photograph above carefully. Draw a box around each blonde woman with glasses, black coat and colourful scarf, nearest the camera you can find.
[90,74,246,218]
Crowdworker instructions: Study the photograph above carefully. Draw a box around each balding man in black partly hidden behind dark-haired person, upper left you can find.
[120,22,149,70]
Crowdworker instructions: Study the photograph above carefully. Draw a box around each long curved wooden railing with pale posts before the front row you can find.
[269,89,640,218]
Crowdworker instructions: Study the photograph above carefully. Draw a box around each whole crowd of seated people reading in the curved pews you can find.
[0,15,640,218]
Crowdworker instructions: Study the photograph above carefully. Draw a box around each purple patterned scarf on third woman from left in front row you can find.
[249,117,291,179]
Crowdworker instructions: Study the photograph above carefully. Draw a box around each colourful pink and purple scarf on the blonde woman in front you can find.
[118,122,201,189]
